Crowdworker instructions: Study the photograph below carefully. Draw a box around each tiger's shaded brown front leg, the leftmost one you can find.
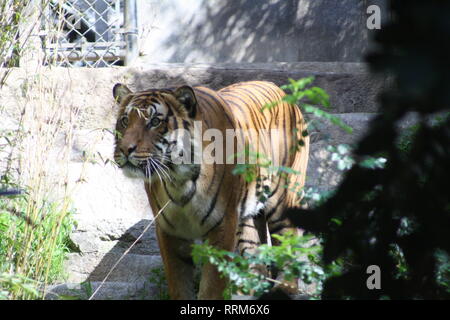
[156,224,195,300]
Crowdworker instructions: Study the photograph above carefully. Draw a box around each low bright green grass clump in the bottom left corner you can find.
[0,186,73,299]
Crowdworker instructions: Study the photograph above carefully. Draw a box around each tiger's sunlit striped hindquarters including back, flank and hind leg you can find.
[218,81,309,254]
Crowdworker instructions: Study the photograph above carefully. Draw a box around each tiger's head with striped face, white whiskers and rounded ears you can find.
[113,84,197,182]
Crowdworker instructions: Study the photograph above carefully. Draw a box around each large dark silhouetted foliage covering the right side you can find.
[287,0,450,299]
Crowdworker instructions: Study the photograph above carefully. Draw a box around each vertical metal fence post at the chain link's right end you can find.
[124,0,138,66]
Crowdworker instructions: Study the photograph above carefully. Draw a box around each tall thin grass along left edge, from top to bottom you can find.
[0,0,82,299]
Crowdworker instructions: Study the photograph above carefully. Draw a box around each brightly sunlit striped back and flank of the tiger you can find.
[218,81,309,209]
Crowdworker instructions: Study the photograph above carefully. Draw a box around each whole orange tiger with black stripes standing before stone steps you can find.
[113,81,309,299]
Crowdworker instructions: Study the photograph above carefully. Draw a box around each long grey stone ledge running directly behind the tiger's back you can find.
[125,62,386,113]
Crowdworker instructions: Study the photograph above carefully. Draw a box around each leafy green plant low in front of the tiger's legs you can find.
[192,234,325,298]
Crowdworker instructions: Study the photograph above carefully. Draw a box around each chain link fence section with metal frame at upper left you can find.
[39,0,137,67]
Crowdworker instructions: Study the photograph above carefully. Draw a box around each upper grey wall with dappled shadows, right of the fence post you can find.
[141,0,385,63]
